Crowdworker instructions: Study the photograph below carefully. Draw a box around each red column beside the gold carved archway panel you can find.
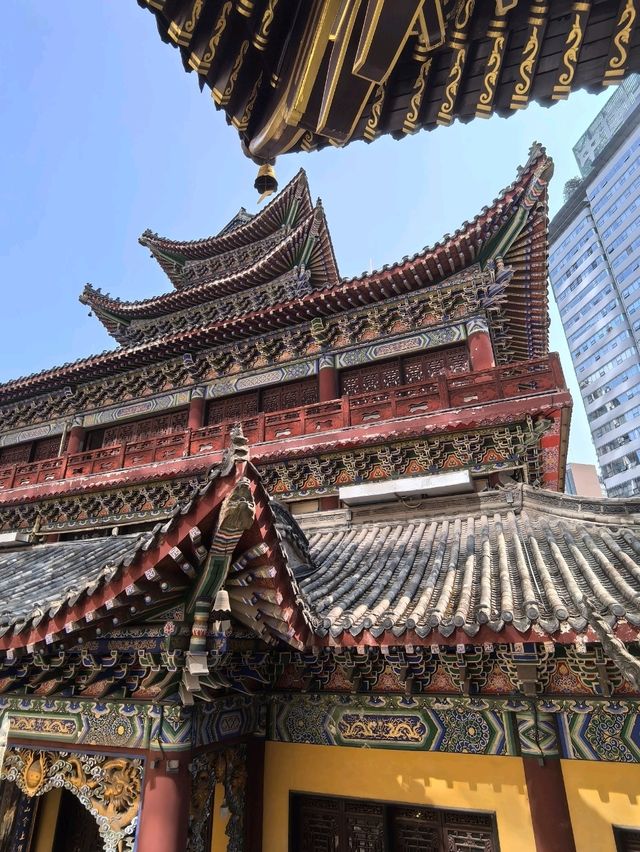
[136,752,191,852]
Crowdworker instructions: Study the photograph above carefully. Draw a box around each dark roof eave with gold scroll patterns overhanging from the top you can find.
[138,0,640,169]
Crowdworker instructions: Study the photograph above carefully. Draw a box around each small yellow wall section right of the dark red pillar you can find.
[562,760,640,852]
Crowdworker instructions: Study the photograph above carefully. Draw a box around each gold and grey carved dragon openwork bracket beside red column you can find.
[0,746,143,852]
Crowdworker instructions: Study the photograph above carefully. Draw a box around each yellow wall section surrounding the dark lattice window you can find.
[262,742,536,852]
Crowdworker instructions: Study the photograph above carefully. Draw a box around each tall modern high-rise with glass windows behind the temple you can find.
[549,78,640,497]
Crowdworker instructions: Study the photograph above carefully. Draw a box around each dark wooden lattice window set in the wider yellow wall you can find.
[289,794,499,852]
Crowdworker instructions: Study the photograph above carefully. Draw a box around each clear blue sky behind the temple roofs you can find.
[0,0,608,462]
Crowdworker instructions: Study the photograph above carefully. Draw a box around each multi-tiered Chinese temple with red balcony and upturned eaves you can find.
[0,145,640,852]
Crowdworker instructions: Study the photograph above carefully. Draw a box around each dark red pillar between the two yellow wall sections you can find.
[522,757,576,852]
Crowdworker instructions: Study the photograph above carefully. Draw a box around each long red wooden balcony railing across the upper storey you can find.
[0,354,565,490]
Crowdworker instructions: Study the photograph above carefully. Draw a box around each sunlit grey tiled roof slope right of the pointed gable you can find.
[300,486,640,642]
